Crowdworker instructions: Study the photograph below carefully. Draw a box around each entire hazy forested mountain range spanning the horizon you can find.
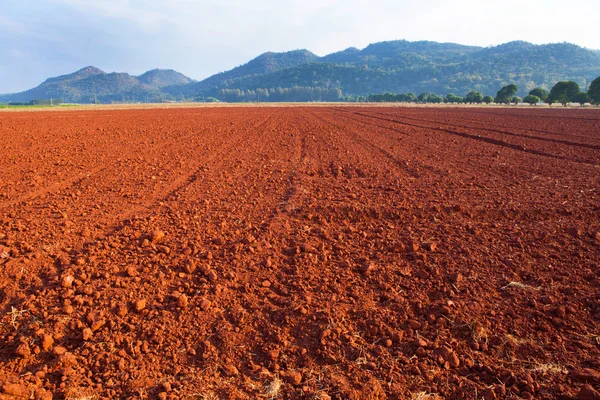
[0,40,600,103]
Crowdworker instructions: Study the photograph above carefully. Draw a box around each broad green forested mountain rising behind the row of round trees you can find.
[189,40,600,97]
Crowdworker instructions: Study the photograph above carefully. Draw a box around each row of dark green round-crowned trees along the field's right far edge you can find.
[366,77,600,106]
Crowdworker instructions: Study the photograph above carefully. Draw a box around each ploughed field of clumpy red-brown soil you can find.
[0,106,600,400]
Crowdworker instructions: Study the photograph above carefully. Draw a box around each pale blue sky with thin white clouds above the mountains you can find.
[0,0,600,93]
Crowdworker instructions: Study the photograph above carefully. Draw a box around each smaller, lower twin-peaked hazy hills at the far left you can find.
[0,66,195,103]
